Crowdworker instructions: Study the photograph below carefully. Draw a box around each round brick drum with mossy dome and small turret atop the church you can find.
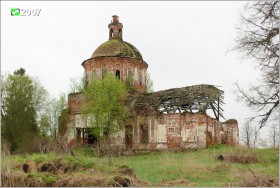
[82,15,148,93]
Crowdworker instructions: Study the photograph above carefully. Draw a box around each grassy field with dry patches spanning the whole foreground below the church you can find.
[2,145,279,187]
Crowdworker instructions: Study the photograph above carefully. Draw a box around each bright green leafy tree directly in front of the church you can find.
[82,73,128,146]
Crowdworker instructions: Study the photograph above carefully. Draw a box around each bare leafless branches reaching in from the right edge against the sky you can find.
[234,1,279,128]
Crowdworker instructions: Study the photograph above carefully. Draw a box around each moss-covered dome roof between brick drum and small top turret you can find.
[91,37,143,61]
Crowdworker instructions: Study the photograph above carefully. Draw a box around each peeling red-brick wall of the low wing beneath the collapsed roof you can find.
[127,113,238,149]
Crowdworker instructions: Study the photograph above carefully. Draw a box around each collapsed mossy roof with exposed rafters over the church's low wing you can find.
[133,84,224,120]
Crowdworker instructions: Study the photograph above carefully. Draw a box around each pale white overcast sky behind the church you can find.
[1,1,272,140]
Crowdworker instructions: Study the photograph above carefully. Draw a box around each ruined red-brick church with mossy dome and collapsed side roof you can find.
[67,16,239,149]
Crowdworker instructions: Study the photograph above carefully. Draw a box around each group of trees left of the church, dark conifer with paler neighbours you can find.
[1,68,67,153]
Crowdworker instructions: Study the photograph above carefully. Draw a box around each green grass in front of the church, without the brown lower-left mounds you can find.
[1,145,279,186]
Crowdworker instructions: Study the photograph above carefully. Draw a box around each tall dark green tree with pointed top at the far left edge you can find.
[1,68,47,152]
